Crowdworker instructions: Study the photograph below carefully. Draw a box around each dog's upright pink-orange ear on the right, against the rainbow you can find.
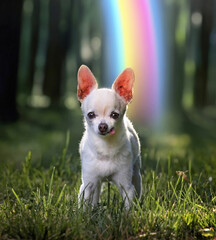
[112,68,135,103]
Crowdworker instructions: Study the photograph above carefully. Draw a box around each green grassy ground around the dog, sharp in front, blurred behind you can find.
[0,109,216,239]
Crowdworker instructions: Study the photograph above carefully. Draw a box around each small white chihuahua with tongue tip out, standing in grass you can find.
[77,65,142,208]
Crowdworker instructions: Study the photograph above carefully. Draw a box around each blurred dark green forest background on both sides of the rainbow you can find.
[0,0,216,163]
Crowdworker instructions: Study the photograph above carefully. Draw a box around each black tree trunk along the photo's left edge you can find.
[0,0,22,121]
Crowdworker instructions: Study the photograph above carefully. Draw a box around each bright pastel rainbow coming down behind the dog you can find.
[101,0,167,124]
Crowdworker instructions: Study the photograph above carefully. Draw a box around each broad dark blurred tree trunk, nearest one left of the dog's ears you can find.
[43,0,72,105]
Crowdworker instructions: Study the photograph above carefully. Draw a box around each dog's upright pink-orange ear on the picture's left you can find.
[77,65,98,102]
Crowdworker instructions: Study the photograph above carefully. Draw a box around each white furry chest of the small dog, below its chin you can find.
[80,130,133,178]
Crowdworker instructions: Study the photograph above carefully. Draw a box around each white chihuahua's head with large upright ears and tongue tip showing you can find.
[77,65,134,136]
